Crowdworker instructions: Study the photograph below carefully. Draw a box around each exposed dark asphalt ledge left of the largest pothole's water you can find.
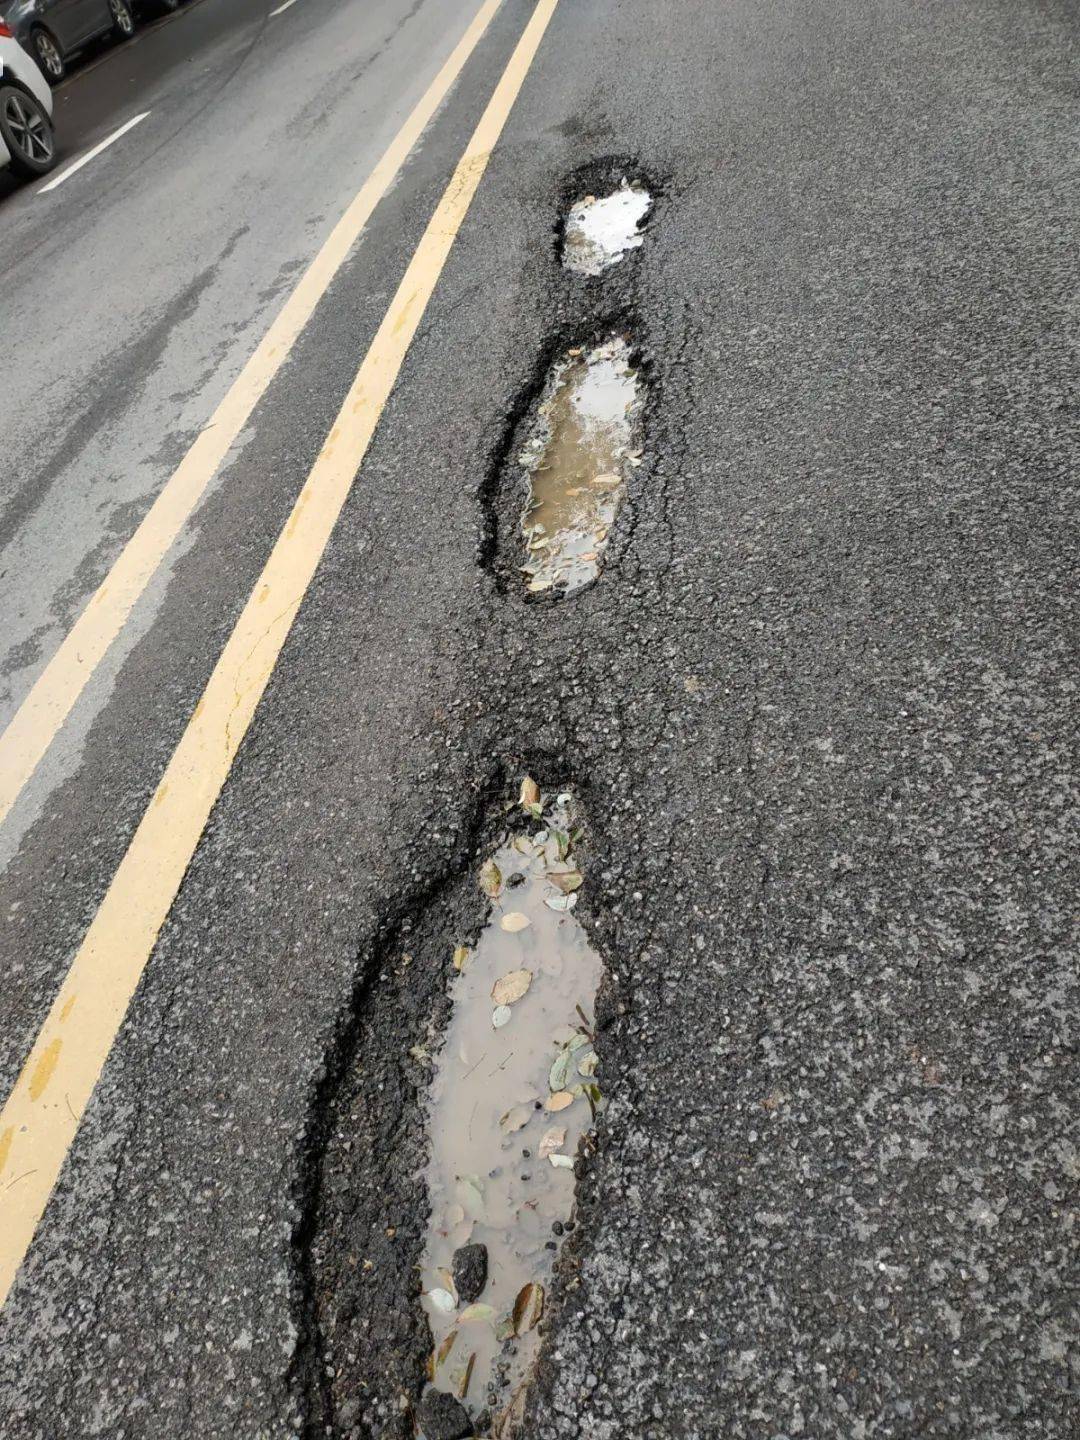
[294,789,491,1440]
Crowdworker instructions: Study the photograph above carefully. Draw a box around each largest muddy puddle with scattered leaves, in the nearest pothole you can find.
[420,782,602,1437]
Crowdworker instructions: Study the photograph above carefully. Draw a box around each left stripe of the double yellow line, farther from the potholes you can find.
[0,0,503,824]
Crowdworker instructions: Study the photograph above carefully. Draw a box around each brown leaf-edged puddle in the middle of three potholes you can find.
[520,336,642,596]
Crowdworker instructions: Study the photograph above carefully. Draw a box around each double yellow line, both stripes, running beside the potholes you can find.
[0,0,557,1305]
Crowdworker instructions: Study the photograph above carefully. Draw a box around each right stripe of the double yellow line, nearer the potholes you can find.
[0,0,557,1305]
